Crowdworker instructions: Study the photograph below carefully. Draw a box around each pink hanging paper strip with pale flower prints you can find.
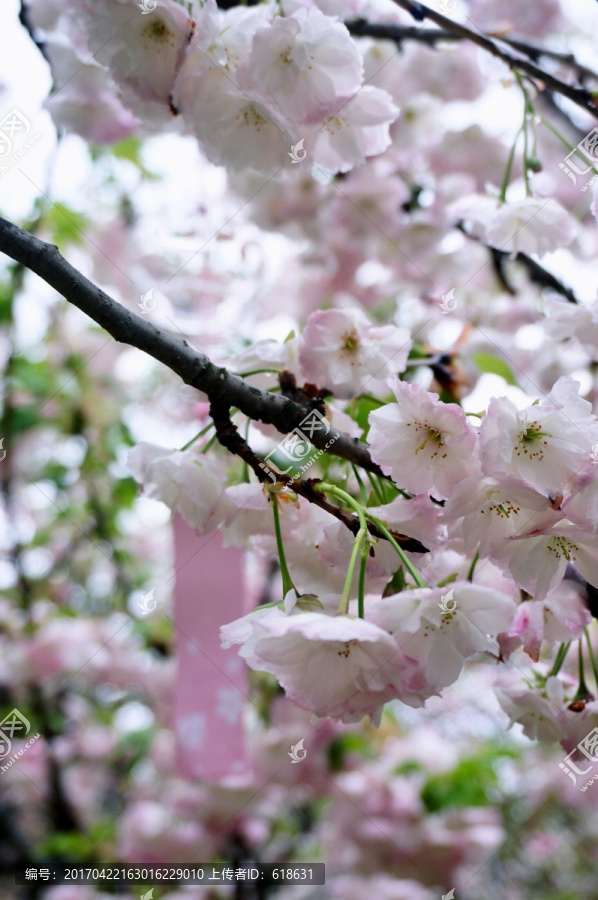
[173,515,251,781]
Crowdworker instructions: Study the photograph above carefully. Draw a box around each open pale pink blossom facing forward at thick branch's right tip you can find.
[369,378,477,498]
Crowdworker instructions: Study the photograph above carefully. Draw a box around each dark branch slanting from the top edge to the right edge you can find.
[394,0,598,118]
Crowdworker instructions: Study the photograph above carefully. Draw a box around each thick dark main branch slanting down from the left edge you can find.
[0,218,386,478]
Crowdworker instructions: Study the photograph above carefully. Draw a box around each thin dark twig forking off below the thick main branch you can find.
[210,403,428,553]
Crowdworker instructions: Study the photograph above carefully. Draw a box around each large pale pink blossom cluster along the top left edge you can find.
[31,0,399,176]
